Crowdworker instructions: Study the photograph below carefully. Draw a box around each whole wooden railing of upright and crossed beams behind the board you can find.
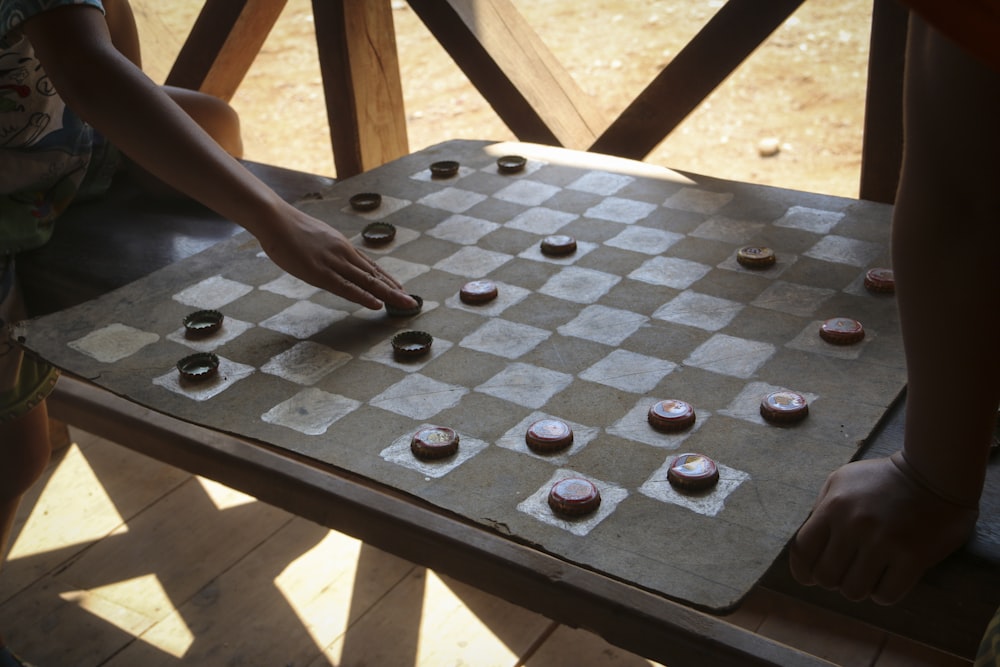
[167,0,907,202]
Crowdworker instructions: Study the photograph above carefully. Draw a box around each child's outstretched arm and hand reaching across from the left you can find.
[22,6,415,309]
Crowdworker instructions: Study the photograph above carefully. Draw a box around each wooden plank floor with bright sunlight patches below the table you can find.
[0,431,968,667]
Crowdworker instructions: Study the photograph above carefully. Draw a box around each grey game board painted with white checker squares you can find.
[22,141,905,610]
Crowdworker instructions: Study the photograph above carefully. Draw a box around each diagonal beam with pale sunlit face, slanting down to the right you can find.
[409,0,607,149]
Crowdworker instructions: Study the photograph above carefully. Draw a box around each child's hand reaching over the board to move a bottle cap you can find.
[257,207,417,310]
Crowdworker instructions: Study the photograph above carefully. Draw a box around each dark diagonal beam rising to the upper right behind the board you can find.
[589,0,803,160]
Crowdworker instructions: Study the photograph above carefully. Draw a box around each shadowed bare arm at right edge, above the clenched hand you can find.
[893,15,1000,503]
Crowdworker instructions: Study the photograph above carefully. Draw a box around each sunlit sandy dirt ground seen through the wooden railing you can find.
[133,0,871,196]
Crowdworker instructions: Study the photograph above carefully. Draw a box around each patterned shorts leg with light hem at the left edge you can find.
[0,255,59,422]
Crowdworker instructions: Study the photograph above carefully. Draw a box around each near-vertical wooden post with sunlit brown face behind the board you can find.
[313,0,409,178]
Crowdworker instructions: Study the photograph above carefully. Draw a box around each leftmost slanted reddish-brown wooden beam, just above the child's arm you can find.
[166,0,286,102]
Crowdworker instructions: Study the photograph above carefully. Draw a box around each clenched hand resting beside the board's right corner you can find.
[789,454,978,604]
